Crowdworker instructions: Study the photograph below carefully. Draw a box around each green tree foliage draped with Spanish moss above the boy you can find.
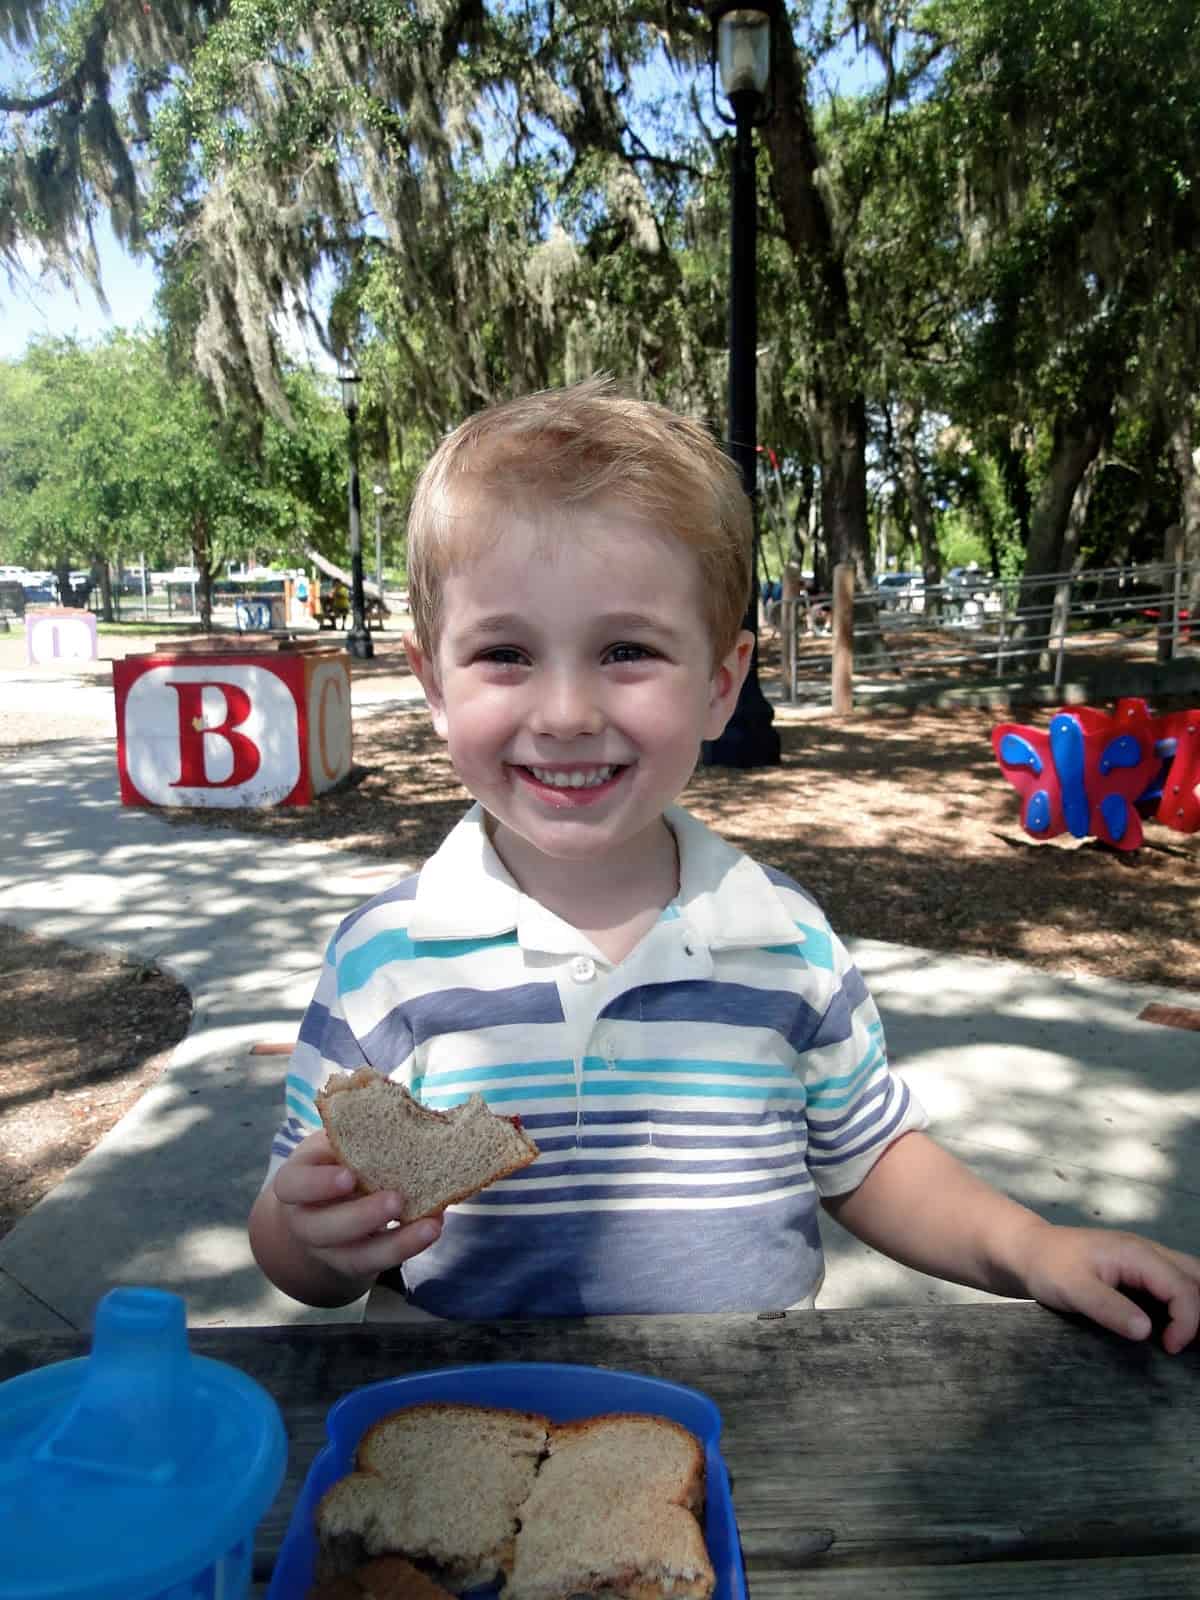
[0,0,1200,592]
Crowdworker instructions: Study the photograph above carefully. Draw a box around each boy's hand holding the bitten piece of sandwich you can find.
[272,1133,442,1282]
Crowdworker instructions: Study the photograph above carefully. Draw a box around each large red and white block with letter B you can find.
[112,650,350,806]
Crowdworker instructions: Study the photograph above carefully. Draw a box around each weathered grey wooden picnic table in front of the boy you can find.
[0,1302,1200,1600]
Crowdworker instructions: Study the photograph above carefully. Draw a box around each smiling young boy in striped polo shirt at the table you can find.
[250,381,1200,1352]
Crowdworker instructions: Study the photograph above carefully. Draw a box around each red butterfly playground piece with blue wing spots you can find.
[992,699,1200,850]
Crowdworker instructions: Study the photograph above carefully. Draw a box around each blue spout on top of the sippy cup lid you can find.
[35,1288,192,1483]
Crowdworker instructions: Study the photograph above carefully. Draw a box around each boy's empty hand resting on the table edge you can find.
[1021,1219,1200,1355]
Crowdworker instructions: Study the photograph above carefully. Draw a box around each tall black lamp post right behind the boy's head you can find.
[702,0,781,766]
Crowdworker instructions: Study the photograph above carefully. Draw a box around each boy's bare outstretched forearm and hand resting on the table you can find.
[824,1133,1200,1354]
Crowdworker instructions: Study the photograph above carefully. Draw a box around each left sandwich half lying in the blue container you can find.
[317,1403,549,1594]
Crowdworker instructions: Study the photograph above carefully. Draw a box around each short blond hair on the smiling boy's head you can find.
[408,378,754,659]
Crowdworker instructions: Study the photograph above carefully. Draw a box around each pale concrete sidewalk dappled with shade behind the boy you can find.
[0,675,1200,1330]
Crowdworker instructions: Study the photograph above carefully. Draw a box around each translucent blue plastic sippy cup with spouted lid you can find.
[0,1288,286,1600]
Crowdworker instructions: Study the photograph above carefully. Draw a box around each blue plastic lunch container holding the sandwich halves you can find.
[267,1362,746,1600]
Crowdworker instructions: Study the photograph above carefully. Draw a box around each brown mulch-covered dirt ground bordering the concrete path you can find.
[0,635,1200,1232]
